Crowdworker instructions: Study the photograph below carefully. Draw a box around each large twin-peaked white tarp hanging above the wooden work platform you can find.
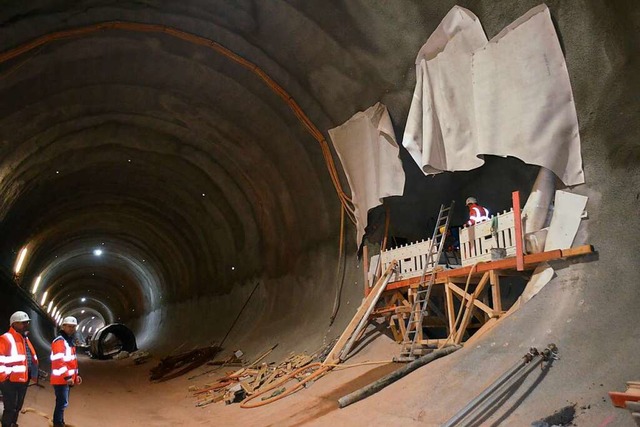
[403,5,584,185]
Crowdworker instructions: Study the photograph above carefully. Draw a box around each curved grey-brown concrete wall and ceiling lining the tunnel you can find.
[0,0,640,422]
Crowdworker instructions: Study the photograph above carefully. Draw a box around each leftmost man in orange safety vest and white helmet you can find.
[0,311,38,427]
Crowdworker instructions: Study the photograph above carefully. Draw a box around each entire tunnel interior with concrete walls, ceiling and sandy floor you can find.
[0,0,640,426]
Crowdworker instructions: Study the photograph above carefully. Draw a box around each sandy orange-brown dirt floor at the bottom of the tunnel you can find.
[19,336,424,427]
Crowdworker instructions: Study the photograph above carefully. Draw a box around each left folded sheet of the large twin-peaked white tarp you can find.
[402,6,487,174]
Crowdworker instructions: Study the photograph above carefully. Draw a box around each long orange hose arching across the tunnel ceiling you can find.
[0,21,355,223]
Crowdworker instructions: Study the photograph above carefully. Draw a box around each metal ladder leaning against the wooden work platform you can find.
[394,201,455,362]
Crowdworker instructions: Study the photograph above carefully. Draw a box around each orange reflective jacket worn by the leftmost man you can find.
[0,328,38,383]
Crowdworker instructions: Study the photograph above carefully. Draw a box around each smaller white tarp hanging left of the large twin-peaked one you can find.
[329,103,405,245]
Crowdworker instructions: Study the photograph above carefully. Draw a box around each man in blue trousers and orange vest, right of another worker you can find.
[51,316,82,427]
